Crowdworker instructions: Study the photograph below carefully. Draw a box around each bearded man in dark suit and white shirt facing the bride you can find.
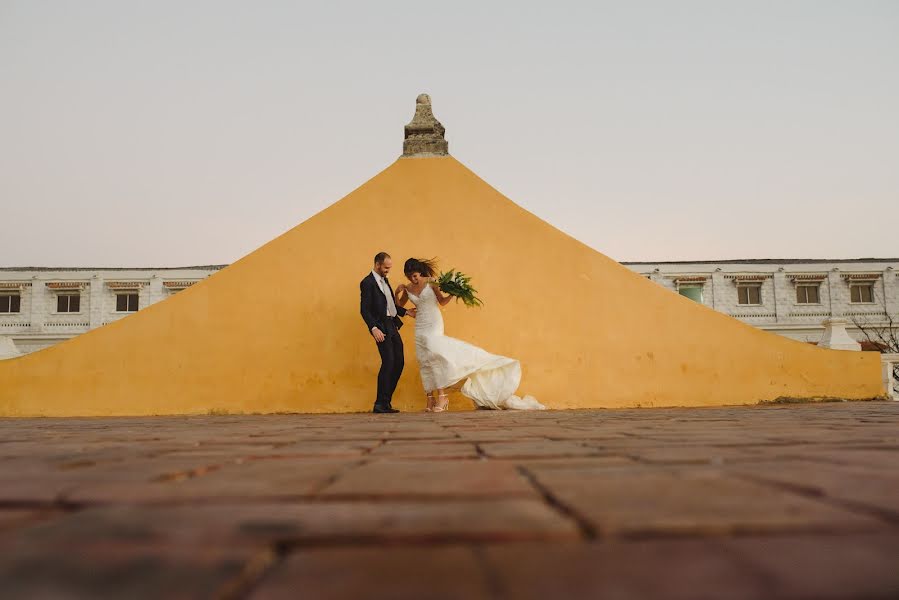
[359,252,415,413]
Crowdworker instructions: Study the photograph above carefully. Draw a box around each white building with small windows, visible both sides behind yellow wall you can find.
[0,259,899,358]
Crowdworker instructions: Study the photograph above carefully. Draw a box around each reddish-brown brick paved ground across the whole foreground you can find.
[0,403,899,599]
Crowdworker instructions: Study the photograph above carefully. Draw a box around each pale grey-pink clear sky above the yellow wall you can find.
[0,0,899,266]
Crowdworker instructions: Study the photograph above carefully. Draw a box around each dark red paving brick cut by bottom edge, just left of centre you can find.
[250,546,493,600]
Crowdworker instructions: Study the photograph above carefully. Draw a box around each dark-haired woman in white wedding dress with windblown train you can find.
[396,258,545,412]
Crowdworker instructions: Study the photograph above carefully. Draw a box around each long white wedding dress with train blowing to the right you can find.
[408,285,546,410]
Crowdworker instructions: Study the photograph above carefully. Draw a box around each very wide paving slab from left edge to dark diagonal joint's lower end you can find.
[0,499,580,548]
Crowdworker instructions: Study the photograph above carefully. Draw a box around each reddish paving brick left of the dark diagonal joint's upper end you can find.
[322,460,536,497]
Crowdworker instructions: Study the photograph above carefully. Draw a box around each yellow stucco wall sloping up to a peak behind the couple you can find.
[0,157,883,416]
